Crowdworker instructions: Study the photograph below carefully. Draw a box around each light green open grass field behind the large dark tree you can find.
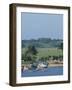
[22,48,63,57]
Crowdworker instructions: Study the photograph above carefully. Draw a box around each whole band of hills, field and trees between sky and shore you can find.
[22,38,63,63]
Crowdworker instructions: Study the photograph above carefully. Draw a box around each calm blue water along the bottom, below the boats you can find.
[21,66,63,77]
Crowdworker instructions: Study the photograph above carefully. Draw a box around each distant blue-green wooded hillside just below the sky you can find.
[22,38,63,48]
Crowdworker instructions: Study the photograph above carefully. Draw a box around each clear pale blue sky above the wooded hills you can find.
[21,12,63,40]
